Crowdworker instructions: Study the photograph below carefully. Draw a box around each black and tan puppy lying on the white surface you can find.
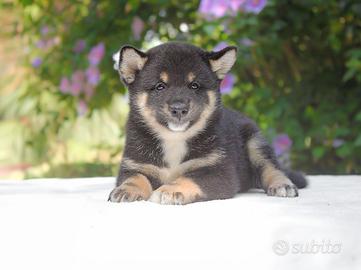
[109,43,306,204]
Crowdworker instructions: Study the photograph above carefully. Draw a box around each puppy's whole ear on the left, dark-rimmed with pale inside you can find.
[113,45,148,85]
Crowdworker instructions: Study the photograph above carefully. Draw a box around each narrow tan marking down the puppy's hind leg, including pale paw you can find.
[247,136,298,197]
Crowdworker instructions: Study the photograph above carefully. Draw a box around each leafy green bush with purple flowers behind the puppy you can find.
[4,0,361,173]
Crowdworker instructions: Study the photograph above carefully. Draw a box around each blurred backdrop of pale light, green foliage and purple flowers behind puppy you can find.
[0,0,361,179]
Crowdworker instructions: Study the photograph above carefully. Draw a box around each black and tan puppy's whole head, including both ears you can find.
[113,43,236,132]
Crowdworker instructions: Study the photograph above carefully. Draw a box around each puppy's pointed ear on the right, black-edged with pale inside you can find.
[208,46,237,80]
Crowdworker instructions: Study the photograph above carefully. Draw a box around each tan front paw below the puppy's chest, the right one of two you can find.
[149,177,204,204]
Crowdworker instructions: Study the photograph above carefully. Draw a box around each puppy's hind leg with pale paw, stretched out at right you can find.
[247,133,298,197]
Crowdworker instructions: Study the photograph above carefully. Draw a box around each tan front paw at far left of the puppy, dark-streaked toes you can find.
[109,174,153,202]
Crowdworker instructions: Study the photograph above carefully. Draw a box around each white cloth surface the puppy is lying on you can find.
[0,176,361,270]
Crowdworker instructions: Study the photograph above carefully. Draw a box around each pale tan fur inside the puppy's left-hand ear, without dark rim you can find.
[119,48,148,83]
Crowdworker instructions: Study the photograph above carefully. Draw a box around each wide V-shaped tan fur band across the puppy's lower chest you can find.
[123,150,224,184]
